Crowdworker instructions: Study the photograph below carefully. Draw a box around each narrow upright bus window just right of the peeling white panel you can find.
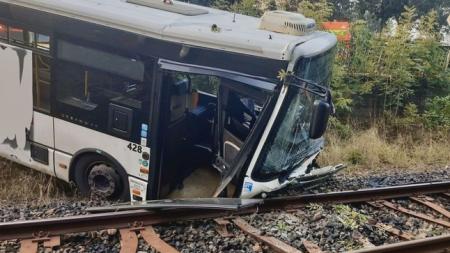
[33,54,51,112]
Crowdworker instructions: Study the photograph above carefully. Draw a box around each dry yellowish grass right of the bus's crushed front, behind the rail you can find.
[319,127,450,174]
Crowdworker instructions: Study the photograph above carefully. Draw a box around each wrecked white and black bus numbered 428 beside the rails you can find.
[0,0,341,201]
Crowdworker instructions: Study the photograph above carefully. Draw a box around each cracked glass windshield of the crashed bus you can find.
[252,49,334,182]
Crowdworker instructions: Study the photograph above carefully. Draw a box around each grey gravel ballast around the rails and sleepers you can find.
[0,169,450,253]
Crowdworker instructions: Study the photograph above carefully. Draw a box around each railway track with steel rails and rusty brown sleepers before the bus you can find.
[0,181,450,253]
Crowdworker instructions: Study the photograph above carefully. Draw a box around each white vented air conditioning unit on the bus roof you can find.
[259,11,316,36]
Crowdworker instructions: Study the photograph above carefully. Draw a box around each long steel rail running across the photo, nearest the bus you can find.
[0,181,450,241]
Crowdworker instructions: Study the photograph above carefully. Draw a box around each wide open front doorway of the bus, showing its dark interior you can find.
[159,60,276,197]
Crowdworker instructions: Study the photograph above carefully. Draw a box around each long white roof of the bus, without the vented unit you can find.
[0,0,324,60]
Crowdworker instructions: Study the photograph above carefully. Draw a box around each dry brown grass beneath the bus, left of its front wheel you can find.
[0,159,75,204]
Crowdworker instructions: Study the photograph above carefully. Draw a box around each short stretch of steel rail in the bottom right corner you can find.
[351,235,450,253]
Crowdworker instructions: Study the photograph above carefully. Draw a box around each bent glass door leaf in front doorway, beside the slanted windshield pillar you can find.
[215,79,269,196]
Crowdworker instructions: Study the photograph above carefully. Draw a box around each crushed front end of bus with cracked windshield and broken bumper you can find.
[241,32,344,198]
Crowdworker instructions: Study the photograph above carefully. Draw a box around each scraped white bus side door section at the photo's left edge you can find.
[0,36,54,175]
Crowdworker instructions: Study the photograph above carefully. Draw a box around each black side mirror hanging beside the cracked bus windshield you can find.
[309,100,331,140]
